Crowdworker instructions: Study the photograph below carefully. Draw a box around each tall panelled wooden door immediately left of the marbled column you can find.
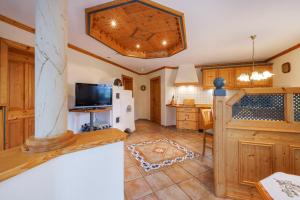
[5,50,34,149]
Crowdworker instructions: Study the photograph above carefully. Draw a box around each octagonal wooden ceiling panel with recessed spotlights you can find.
[86,0,186,58]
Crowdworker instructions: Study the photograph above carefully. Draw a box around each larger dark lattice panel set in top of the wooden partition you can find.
[232,94,285,121]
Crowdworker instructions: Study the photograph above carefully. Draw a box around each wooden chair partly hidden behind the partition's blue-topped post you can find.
[200,109,214,156]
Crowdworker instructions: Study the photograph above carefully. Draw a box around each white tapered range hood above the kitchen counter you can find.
[175,64,199,86]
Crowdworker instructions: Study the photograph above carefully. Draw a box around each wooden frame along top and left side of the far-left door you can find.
[0,37,34,151]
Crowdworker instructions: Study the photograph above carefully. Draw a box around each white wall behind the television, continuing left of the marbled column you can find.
[0,22,149,131]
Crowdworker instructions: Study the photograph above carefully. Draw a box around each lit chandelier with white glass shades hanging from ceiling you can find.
[237,35,274,82]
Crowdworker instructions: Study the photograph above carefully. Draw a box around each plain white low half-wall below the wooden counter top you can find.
[0,142,124,200]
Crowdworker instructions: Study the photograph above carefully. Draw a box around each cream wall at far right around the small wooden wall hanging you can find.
[270,48,300,87]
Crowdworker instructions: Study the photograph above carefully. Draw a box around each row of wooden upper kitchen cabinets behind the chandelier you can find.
[202,65,273,89]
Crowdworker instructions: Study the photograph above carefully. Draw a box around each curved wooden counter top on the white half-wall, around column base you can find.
[0,128,127,182]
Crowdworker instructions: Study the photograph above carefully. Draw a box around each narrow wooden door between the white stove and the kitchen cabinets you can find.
[150,77,161,124]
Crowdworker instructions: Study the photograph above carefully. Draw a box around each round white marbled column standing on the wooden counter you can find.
[35,0,68,138]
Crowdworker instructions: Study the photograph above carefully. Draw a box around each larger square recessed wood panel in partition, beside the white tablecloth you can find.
[239,141,275,184]
